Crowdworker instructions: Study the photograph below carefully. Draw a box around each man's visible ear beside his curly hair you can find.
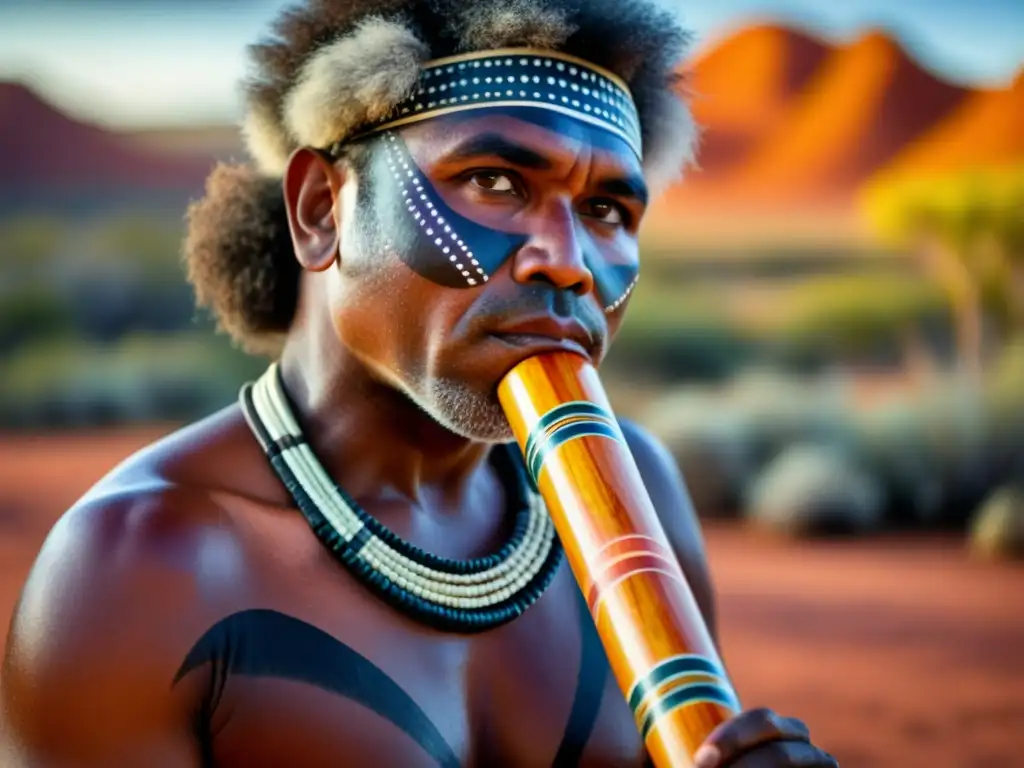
[282,147,345,272]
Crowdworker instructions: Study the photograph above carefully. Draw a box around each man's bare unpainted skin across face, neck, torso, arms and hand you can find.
[0,111,835,768]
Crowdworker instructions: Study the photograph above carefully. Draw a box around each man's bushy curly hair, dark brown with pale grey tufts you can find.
[184,0,697,356]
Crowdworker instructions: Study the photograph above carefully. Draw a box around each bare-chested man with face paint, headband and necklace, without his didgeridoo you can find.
[2,0,835,768]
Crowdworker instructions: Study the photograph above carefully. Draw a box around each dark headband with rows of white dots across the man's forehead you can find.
[346,48,643,160]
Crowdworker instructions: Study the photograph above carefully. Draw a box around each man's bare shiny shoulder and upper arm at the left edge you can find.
[0,405,268,765]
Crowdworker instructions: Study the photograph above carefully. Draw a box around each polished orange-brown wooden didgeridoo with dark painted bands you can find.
[498,352,740,768]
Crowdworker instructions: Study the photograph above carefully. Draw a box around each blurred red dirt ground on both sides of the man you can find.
[0,429,1024,768]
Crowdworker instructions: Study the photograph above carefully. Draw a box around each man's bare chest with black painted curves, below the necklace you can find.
[196,568,644,768]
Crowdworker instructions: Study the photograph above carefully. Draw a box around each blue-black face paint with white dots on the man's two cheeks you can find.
[371,131,640,312]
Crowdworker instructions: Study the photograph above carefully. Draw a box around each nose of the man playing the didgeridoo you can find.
[512,203,594,296]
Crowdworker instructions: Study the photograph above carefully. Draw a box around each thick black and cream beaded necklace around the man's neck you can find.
[239,364,562,633]
